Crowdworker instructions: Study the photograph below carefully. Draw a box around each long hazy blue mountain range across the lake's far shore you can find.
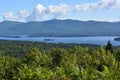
[0,19,120,36]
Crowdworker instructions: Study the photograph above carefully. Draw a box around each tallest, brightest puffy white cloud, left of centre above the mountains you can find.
[27,4,69,21]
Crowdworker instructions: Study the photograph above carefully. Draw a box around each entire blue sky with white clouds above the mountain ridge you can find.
[0,0,120,22]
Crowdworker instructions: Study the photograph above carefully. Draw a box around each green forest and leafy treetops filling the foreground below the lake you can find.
[0,40,120,80]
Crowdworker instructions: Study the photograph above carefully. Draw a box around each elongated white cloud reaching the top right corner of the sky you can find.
[74,0,120,12]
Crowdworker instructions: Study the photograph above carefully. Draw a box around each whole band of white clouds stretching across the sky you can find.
[3,0,120,21]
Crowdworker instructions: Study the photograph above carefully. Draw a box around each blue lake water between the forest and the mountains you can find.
[0,36,120,46]
